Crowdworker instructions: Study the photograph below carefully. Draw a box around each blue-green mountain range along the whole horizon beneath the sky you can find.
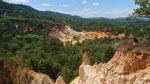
[0,0,150,22]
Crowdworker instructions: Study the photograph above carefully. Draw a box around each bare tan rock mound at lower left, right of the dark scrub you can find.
[13,67,54,84]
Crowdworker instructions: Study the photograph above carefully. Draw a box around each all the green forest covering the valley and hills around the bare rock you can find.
[0,0,150,84]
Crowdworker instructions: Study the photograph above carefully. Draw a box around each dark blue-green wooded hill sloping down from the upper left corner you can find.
[0,0,81,19]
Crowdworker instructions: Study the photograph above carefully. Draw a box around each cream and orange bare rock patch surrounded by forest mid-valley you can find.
[48,26,125,44]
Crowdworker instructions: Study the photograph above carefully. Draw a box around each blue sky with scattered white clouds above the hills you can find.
[4,0,138,18]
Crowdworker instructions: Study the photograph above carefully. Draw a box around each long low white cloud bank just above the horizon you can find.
[57,8,132,18]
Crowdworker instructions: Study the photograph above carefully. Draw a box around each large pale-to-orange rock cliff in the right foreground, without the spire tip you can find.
[70,49,150,84]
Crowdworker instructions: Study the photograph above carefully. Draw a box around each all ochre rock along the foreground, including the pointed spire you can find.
[0,46,150,84]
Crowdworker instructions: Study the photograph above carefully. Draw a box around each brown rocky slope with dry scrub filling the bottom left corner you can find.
[0,58,55,84]
